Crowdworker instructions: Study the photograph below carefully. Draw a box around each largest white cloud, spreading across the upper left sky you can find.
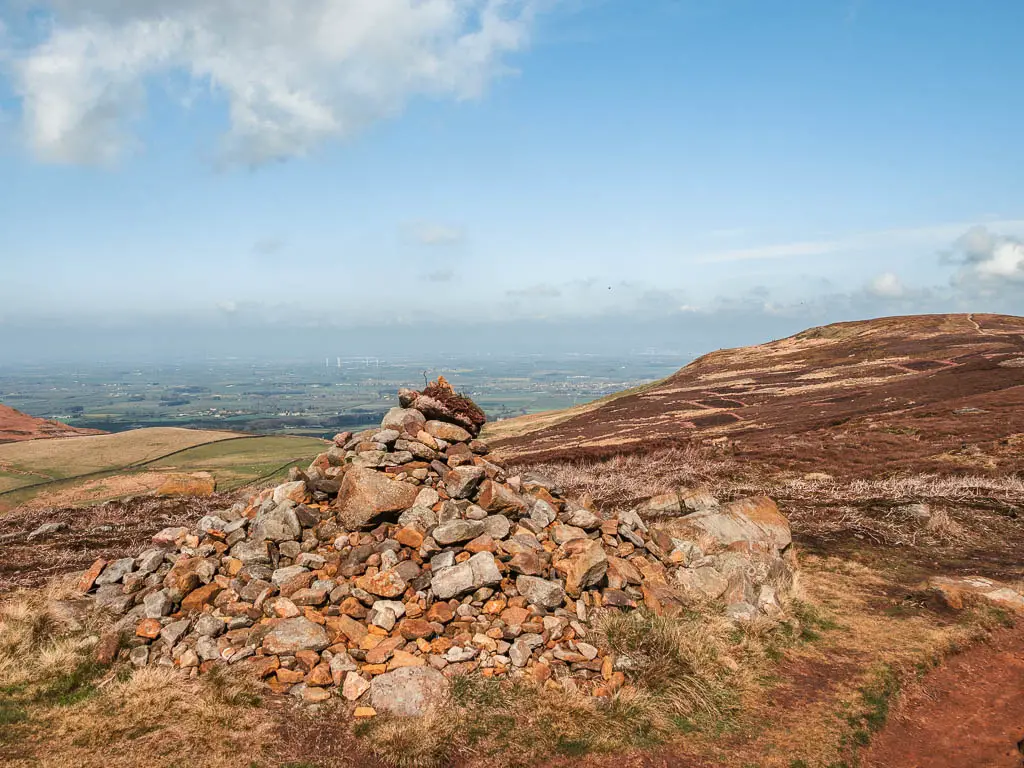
[13,0,536,164]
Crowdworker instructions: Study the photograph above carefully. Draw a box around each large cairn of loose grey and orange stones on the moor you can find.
[80,380,795,714]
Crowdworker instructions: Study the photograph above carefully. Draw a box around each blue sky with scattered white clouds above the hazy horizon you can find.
[0,0,1024,361]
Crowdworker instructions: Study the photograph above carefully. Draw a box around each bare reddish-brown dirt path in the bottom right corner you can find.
[862,629,1024,768]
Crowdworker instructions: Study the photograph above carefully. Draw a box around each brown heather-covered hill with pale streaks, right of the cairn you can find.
[487,314,1024,476]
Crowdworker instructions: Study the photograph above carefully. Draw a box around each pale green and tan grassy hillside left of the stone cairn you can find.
[0,427,326,510]
